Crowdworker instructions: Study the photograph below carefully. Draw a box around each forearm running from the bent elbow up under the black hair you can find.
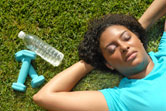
[34,61,93,94]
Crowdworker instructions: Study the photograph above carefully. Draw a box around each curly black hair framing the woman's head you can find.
[78,14,147,71]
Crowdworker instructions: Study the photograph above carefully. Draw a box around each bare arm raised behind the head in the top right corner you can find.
[139,0,166,29]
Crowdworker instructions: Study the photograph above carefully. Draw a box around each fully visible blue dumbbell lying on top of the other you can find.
[12,50,36,92]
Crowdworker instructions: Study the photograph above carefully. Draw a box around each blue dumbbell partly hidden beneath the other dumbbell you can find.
[29,65,45,88]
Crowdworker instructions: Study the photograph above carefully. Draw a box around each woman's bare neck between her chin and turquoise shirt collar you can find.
[128,59,154,79]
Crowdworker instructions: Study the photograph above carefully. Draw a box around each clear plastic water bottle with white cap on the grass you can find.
[18,31,64,66]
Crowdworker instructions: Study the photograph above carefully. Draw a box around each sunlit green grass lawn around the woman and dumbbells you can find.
[0,0,164,111]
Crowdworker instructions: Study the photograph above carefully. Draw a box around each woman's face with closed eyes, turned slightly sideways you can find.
[100,25,150,77]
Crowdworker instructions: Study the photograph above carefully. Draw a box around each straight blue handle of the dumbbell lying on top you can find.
[17,58,31,84]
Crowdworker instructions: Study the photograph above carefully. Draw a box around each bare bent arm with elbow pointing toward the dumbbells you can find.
[33,61,108,111]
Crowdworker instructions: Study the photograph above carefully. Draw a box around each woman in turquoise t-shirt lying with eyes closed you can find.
[33,0,166,111]
